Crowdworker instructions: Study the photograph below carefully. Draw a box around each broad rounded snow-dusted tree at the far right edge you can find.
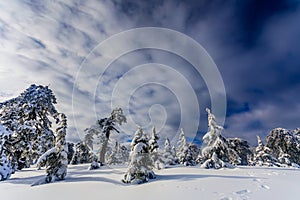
[266,128,300,167]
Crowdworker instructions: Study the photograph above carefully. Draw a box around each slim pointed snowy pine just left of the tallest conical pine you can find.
[177,129,196,166]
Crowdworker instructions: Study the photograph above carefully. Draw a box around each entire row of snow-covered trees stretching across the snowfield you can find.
[0,84,300,183]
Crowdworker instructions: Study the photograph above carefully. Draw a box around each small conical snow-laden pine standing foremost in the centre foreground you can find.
[122,127,155,184]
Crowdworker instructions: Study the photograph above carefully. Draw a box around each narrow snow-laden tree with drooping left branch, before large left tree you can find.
[37,113,68,183]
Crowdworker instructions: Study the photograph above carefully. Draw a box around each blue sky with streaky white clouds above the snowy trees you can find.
[0,0,300,144]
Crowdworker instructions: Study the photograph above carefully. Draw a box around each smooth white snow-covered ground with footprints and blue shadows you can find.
[0,164,300,200]
